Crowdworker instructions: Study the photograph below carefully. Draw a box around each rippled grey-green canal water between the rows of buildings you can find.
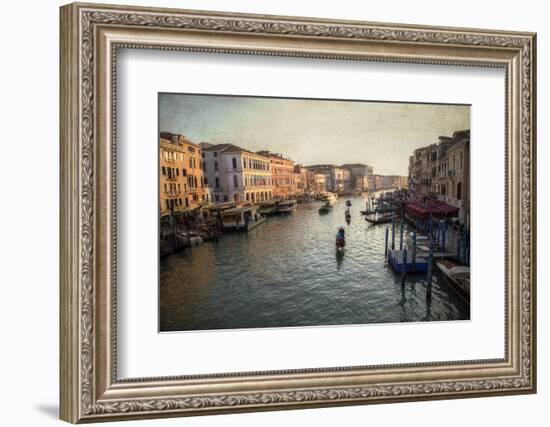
[160,197,470,331]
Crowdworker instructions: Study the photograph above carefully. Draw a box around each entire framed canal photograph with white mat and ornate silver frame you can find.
[60,4,536,423]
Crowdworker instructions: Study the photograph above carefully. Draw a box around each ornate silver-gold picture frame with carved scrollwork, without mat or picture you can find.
[60,4,536,423]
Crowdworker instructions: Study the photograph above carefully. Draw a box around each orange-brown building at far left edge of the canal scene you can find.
[159,132,210,216]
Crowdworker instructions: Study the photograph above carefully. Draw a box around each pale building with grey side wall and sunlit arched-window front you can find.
[201,142,275,203]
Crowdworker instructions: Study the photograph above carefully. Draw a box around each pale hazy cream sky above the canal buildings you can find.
[159,93,470,175]
